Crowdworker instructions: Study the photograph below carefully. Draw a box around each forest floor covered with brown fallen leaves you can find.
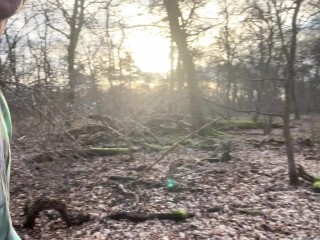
[7,120,320,240]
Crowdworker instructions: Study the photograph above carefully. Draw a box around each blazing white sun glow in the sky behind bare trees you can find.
[129,32,170,73]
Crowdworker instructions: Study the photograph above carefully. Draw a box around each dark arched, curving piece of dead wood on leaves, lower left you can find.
[23,197,90,229]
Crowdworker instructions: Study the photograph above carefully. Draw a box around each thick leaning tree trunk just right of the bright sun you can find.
[163,0,203,128]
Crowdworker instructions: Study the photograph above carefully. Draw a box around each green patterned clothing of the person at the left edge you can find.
[0,91,20,240]
